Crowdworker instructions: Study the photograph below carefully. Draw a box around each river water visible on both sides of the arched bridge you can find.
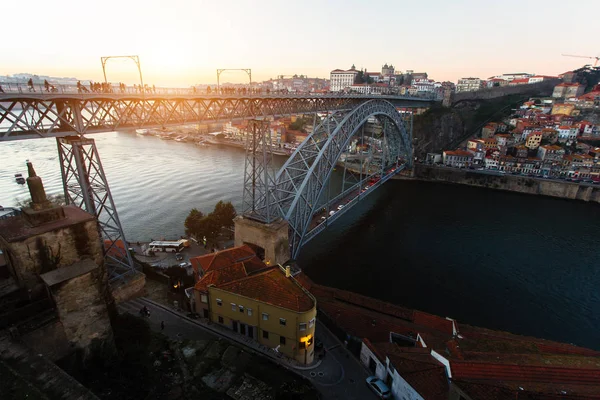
[0,132,600,349]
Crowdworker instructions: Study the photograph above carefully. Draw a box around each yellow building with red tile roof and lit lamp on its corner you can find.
[190,245,317,364]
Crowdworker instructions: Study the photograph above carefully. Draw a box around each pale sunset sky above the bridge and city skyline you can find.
[0,0,600,87]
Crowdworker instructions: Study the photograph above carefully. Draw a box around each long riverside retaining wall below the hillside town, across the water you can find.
[415,164,600,203]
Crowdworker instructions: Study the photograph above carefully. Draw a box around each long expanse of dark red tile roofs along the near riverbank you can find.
[311,284,600,400]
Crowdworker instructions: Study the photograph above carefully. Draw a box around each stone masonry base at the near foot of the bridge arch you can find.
[233,215,290,265]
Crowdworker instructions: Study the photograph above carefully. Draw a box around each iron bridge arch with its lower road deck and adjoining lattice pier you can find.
[244,100,412,258]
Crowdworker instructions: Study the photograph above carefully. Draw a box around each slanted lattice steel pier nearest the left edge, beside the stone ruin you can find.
[56,136,135,282]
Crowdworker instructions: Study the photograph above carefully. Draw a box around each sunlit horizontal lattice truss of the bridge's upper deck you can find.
[0,93,431,141]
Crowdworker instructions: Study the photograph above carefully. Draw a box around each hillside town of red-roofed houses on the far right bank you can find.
[436,72,600,183]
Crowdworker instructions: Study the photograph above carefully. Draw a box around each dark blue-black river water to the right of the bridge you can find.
[299,181,600,349]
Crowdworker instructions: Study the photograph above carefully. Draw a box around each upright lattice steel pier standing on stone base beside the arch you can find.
[242,119,279,224]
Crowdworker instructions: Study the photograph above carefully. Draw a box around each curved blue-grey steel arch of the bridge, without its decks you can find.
[271,100,412,258]
